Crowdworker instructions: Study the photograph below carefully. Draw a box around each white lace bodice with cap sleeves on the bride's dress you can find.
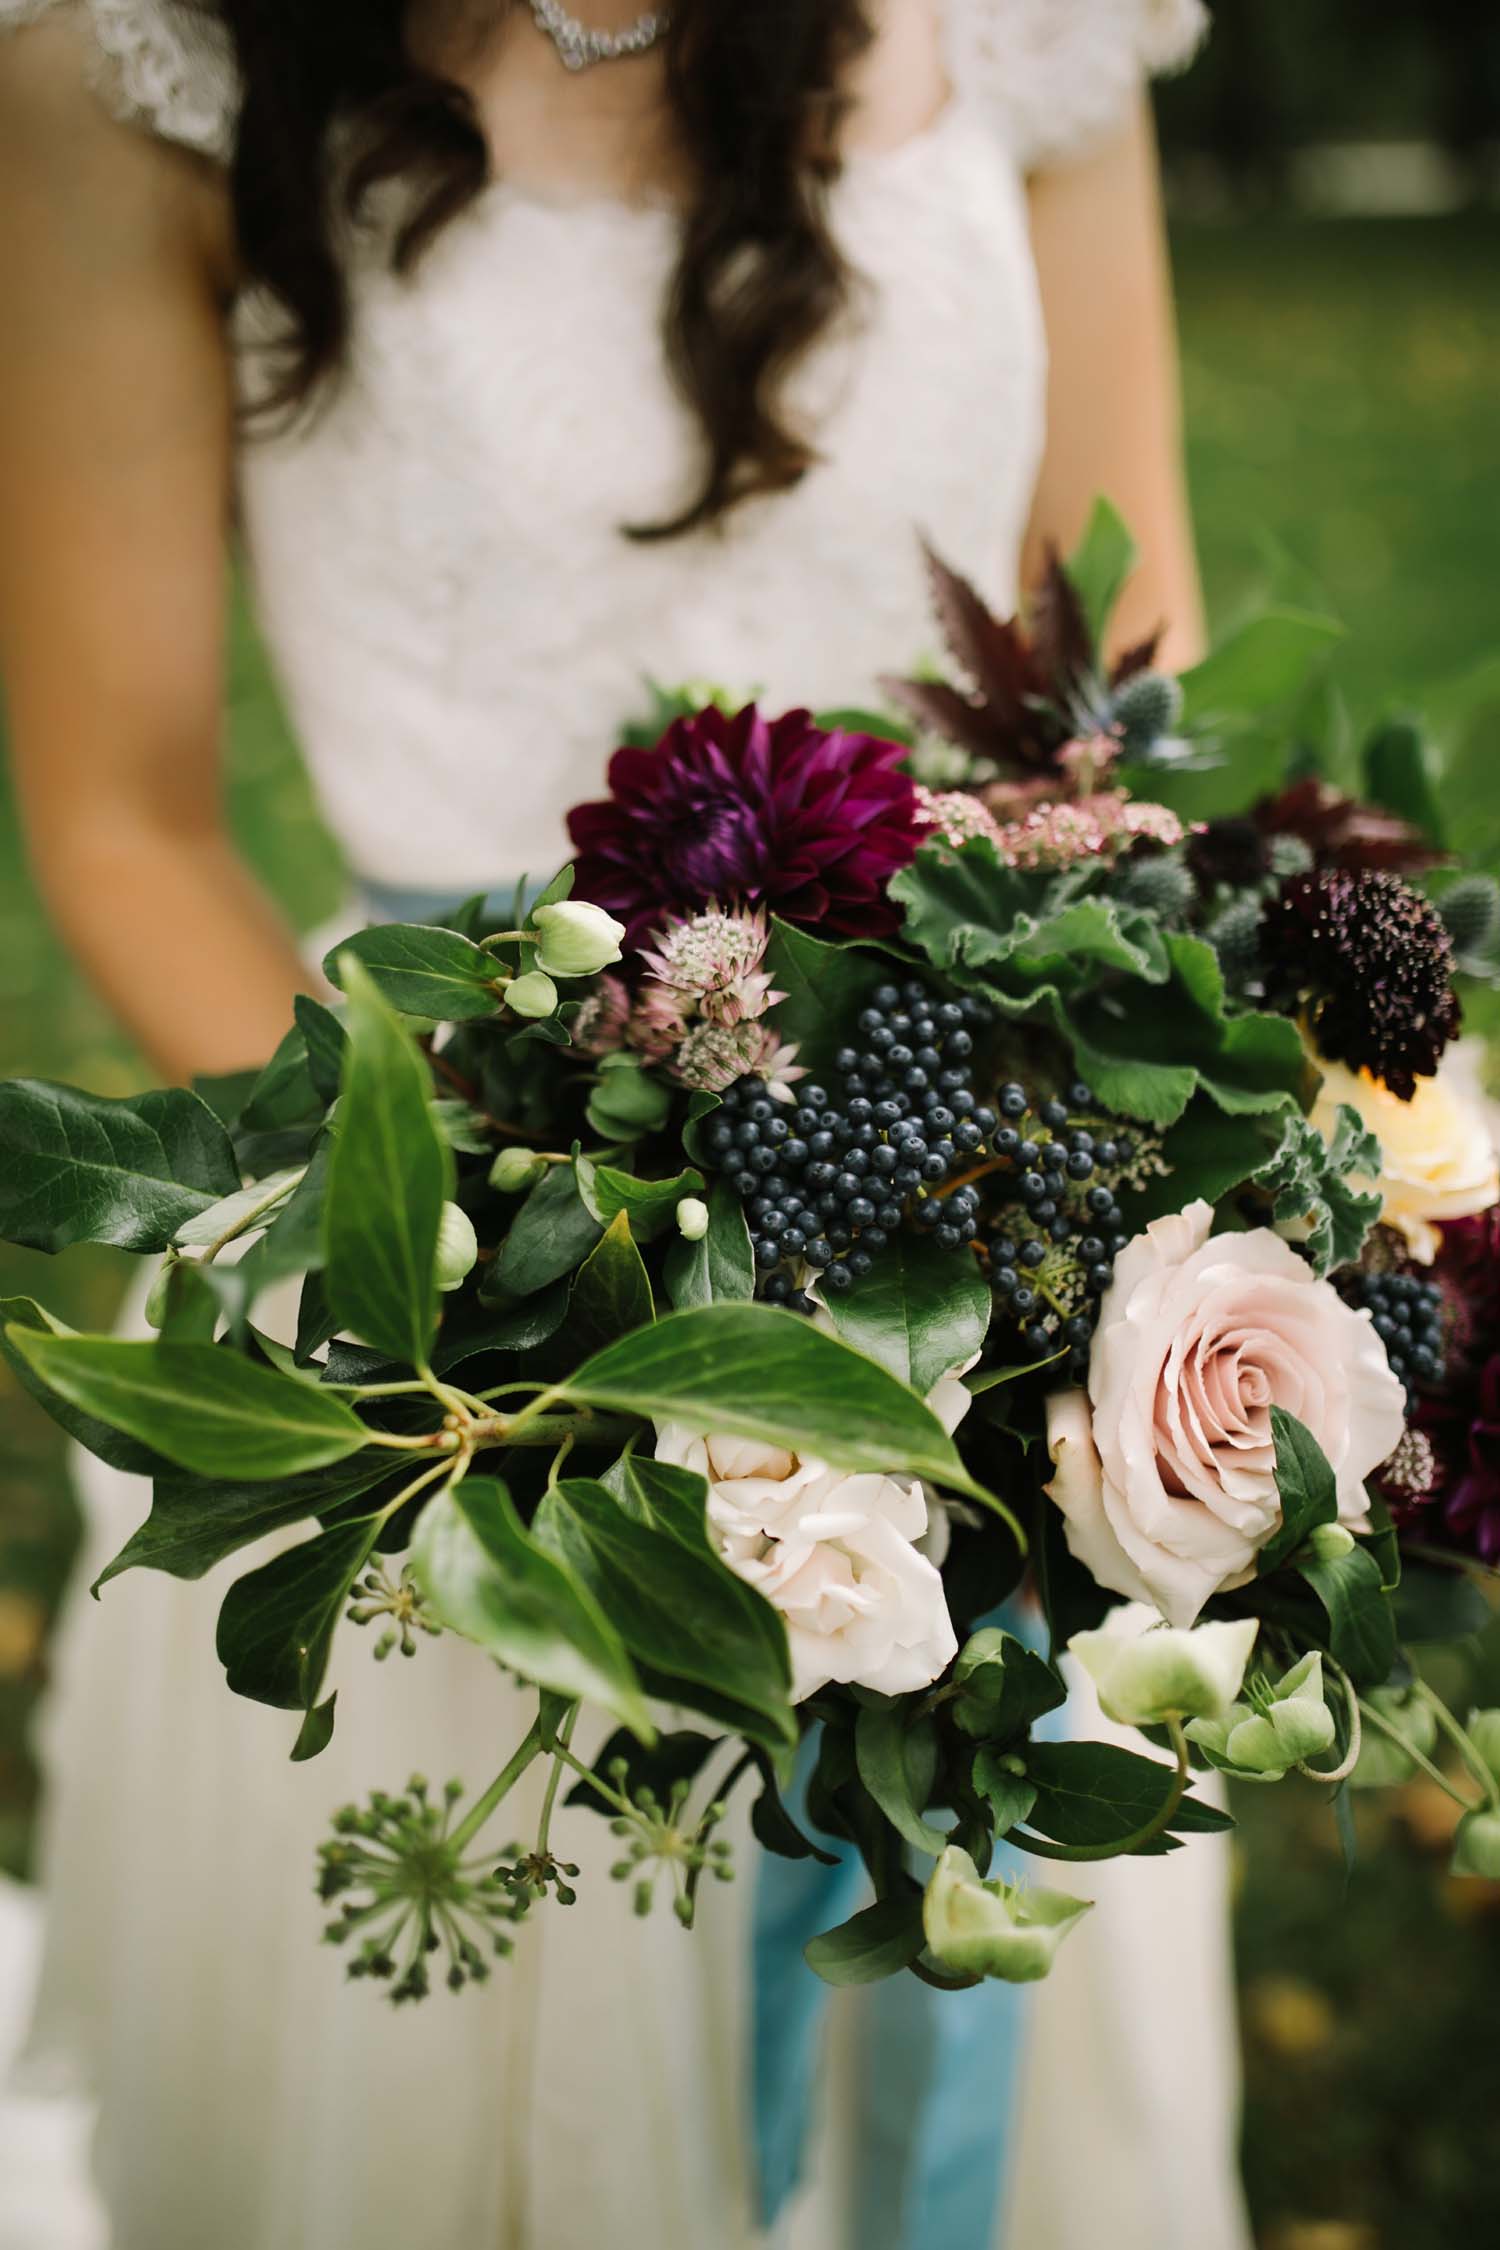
[0,0,1201,893]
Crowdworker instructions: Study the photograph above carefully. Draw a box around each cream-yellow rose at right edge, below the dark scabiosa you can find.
[1313,1049,1500,1265]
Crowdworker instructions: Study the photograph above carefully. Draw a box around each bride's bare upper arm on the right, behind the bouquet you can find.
[1023,99,1203,668]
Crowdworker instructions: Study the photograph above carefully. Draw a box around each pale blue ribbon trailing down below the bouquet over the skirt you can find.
[360,882,1066,2250]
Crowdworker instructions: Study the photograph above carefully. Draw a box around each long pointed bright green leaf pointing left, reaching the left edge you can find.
[9,1325,369,1481]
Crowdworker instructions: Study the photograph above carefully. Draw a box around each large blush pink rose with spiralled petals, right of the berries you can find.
[1048,1204,1406,1625]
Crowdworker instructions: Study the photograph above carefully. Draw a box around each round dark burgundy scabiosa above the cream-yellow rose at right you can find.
[1259,869,1460,1103]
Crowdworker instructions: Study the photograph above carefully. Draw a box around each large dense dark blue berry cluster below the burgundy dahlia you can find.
[708,983,1001,1310]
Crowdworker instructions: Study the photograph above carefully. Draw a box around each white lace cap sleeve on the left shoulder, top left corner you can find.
[0,0,238,162]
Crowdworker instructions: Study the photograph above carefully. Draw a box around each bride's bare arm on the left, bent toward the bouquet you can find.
[0,20,306,1078]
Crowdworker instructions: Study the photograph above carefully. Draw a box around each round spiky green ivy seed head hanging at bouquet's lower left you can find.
[317,1775,524,2000]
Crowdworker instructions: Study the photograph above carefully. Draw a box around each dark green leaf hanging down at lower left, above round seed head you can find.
[218,1517,380,1728]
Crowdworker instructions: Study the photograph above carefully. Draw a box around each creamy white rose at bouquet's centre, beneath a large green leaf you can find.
[657,1422,958,1703]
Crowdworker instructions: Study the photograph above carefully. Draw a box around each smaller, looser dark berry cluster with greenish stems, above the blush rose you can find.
[987,1080,1138,1382]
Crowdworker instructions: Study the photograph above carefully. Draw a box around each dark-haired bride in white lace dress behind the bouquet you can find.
[0,0,1244,2250]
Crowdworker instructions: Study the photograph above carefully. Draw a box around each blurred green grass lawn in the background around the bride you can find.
[0,218,1500,2250]
